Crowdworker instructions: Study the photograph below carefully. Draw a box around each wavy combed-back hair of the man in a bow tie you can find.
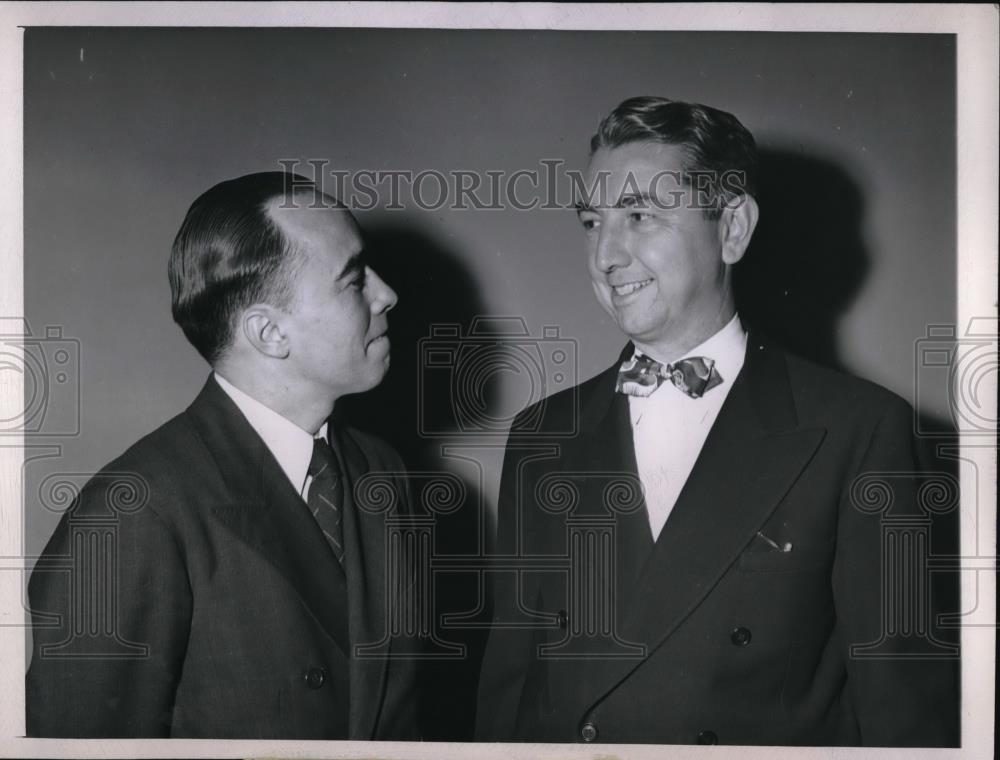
[590,96,758,219]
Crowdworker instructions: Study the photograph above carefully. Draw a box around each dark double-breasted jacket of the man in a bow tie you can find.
[477,334,958,746]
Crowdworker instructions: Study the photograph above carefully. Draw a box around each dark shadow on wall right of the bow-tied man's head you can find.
[733,150,869,369]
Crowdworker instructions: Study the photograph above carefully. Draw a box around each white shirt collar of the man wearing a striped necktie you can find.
[214,372,327,499]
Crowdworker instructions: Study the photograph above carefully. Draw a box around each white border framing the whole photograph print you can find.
[0,2,1000,760]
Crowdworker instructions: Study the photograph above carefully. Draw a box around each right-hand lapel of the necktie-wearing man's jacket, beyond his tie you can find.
[331,425,389,740]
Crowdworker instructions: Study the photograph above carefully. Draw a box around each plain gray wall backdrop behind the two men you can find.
[24,28,956,555]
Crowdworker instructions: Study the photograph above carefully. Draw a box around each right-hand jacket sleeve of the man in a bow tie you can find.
[832,398,960,747]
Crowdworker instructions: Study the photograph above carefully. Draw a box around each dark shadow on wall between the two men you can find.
[337,218,497,741]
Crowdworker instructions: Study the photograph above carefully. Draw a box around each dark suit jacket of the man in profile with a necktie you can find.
[26,379,418,740]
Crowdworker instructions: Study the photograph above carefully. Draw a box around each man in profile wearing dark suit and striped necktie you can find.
[26,172,419,740]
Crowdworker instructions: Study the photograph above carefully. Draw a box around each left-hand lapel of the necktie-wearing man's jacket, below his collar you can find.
[188,378,350,656]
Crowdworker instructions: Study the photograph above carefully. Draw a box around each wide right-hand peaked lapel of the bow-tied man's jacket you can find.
[581,336,825,703]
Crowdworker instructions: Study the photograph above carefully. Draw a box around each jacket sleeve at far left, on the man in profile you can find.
[25,483,192,737]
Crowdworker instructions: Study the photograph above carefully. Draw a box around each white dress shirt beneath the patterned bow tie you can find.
[628,315,747,541]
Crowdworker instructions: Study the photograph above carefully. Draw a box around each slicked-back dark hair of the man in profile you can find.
[167,172,319,365]
